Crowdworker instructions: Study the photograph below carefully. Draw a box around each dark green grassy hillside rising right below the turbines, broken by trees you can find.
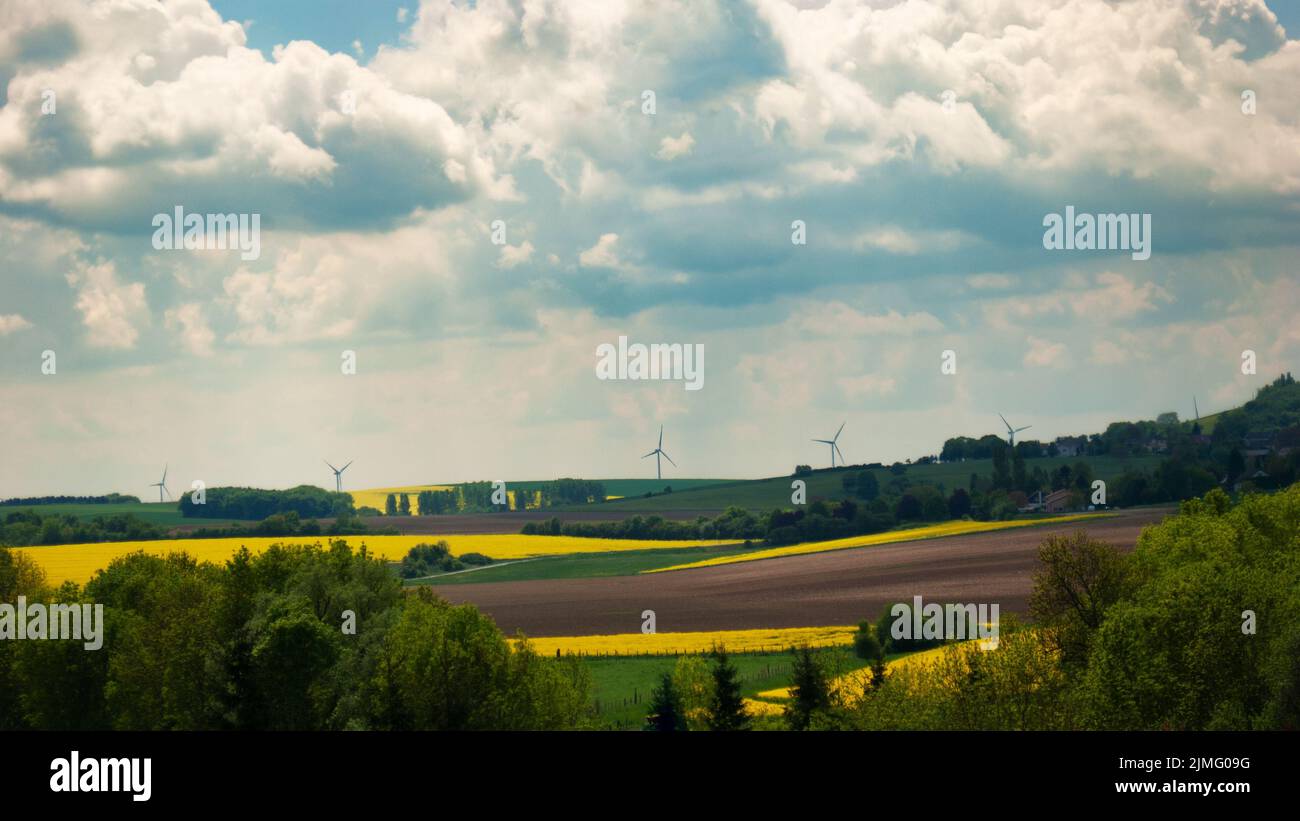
[556,456,1161,513]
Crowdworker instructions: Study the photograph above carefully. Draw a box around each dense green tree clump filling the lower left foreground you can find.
[0,542,589,730]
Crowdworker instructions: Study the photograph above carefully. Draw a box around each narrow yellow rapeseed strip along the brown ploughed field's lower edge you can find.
[512,625,857,656]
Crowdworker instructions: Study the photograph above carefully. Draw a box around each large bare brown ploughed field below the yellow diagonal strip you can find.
[437,509,1170,637]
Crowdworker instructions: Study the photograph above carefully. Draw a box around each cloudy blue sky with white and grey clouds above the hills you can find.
[0,0,1300,498]
